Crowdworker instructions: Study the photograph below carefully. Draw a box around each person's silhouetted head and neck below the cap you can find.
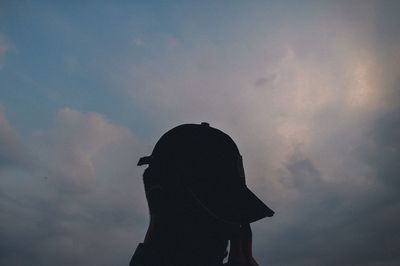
[143,163,233,265]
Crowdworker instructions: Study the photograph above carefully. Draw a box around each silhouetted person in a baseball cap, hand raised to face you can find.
[130,123,274,266]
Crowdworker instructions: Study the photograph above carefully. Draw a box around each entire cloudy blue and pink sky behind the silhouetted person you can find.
[0,0,400,266]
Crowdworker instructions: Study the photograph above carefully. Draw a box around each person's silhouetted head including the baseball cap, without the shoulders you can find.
[138,123,274,264]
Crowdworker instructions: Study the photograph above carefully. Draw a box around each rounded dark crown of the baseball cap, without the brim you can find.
[151,123,245,189]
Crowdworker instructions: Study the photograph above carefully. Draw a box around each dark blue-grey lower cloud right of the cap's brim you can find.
[255,132,400,265]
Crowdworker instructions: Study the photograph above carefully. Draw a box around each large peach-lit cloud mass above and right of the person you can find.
[109,2,400,265]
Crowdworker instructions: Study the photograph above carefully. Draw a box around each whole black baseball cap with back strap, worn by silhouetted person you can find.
[138,122,274,224]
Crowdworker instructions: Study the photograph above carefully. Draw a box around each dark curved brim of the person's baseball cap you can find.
[189,183,275,224]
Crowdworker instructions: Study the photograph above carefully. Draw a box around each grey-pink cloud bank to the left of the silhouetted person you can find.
[0,108,147,266]
